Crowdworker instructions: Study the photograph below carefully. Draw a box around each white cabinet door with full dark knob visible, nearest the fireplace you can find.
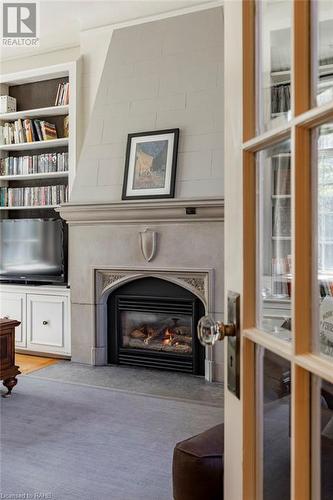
[27,294,69,354]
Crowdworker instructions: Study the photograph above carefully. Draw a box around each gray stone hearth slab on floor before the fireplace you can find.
[29,361,223,407]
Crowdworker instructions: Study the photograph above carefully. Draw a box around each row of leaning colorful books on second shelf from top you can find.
[0,118,57,144]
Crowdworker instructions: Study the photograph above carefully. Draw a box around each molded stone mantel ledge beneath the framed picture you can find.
[56,198,224,225]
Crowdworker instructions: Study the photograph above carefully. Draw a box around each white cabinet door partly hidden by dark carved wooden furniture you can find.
[0,292,27,347]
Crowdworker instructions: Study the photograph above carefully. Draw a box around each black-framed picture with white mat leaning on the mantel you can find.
[122,128,179,200]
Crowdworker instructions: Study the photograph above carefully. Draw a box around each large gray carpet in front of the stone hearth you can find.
[1,376,223,500]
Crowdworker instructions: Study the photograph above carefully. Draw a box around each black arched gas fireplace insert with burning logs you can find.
[108,277,204,375]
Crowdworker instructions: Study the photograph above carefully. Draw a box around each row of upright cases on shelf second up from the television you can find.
[0,153,68,176]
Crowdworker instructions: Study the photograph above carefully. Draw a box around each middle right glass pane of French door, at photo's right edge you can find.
[315,123,333,357]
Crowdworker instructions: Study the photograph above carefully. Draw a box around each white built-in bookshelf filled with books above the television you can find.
[0,61,79,212]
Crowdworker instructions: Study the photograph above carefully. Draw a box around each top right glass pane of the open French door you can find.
[316,0,333,106]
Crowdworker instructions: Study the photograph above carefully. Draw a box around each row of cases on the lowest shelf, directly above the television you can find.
[0,185,68,207]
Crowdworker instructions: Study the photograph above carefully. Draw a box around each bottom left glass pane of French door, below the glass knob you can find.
[263,350,291,500]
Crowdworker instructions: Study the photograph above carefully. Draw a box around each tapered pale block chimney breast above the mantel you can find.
[71,8,224,203]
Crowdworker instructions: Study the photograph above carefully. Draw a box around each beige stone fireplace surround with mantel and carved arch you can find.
[59,198,224,381]
